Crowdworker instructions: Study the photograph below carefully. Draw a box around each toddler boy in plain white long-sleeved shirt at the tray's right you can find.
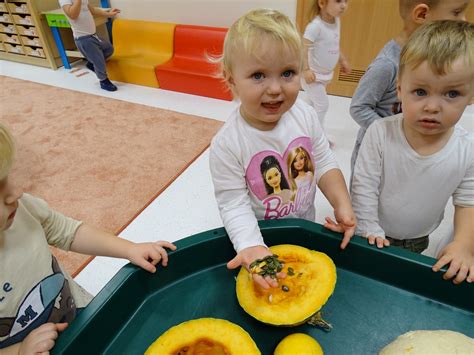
[351,20,474,283]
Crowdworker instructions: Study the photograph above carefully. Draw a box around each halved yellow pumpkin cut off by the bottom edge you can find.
[145,318,261,355]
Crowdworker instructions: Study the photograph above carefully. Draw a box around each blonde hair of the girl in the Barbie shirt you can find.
[221,9,303,90]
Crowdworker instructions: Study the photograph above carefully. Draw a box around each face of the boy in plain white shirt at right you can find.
[397,58,474,138]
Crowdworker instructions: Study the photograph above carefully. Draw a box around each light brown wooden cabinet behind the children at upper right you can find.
[296,0,474,97]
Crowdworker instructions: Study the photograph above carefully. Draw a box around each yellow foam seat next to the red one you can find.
[107,19,176,88]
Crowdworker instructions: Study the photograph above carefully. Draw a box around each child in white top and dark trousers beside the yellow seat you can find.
[59,0,120,91]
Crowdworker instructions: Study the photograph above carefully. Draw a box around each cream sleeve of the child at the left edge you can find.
[22,194,82,250]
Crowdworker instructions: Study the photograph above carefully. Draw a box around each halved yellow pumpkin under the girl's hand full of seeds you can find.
[236,244,336,326]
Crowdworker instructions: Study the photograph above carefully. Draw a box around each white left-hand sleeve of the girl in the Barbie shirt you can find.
[209,137,265,253]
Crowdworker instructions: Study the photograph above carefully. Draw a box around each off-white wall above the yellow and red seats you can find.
[110,0,297,27]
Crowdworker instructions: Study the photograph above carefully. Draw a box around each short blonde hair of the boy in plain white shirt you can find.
[398,20,474,77]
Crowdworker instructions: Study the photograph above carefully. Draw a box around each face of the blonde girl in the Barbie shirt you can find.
[229,36,301,130]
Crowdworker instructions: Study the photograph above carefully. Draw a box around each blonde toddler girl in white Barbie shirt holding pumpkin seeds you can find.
[210,9,355,288]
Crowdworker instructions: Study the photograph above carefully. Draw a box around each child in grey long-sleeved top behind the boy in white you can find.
[350,0,470,173]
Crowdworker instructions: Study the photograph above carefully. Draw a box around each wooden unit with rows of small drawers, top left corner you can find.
[0,0,61,69]
